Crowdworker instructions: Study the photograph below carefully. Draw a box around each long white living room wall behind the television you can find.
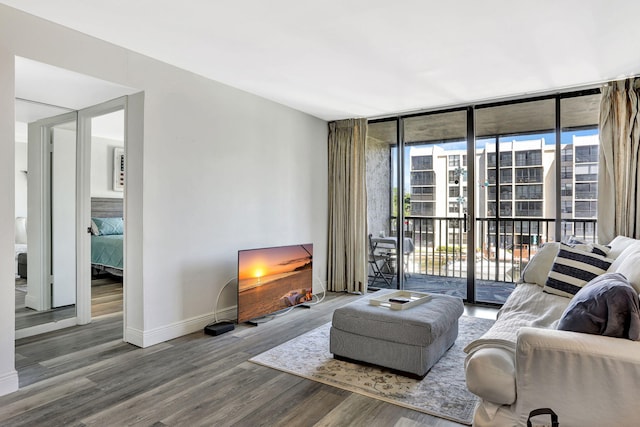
[0,6,327,394]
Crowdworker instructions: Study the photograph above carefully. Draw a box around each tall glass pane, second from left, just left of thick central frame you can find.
[403,110,468,298]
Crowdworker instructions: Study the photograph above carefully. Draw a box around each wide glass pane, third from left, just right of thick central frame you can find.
[476,99,555,303]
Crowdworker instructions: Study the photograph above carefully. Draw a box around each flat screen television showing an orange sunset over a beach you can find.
[238,243,313,323]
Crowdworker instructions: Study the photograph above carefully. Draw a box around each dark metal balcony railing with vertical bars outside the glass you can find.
[390,216,596,283]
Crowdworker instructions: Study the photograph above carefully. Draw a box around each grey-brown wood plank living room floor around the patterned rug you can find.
[0,293,498,427]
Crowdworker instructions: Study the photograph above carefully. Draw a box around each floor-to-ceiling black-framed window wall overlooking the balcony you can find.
[367,90,600,304]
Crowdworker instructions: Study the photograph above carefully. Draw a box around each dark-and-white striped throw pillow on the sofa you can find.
[543,244,613,298]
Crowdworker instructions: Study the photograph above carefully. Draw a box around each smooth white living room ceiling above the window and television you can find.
[5,0,640,120]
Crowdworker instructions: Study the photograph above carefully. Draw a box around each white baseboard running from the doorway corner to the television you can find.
[124,306,236,348]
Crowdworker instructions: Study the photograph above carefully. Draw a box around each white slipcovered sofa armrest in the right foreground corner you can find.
[514,327,640,426]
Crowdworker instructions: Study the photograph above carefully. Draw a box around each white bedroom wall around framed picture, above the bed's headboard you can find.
[91,136,124,199]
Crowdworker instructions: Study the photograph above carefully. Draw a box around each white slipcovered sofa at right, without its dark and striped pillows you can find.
[465,236,640,427]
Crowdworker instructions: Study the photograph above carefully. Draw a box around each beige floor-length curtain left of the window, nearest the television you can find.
[327,119,367,293]
